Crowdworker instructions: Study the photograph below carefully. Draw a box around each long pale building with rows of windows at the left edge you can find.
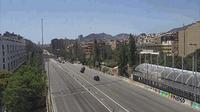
[0,36,26,72]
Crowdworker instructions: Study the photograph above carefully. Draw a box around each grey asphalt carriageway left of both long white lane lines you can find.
[47,63,108,112]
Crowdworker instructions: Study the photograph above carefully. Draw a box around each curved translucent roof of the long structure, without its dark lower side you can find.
[135,63,200,87]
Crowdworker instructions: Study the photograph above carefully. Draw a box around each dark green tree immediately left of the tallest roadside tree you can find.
[118,44,127,76]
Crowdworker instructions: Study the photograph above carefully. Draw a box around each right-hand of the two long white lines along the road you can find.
[59,65,129,112]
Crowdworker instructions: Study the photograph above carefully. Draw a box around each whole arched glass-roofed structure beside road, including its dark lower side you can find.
[134,63,200,102]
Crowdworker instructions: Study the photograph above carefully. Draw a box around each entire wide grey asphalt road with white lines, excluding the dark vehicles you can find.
[46,59,196,112]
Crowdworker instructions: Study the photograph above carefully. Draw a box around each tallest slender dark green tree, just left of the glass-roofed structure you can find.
[128,34,137,67]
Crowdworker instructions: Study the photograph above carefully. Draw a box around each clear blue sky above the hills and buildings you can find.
[0,0,200,43]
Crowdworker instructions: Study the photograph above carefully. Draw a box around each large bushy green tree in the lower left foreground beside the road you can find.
[3,66,46,112]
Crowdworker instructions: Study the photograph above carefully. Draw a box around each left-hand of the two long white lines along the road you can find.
[58,65,112,112]
